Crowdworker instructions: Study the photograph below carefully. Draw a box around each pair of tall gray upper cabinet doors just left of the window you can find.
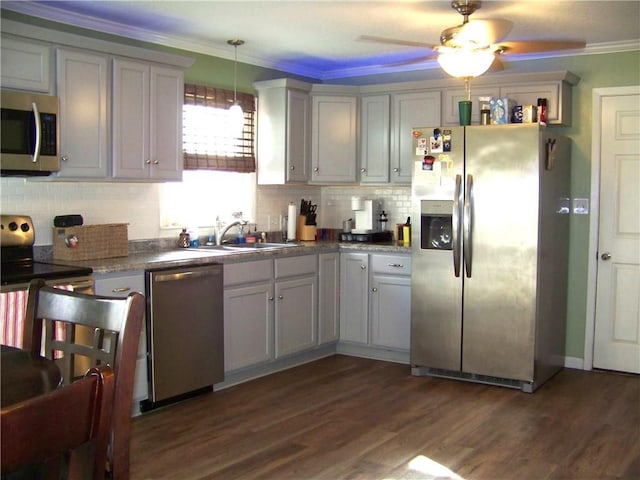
[112,59,184,180]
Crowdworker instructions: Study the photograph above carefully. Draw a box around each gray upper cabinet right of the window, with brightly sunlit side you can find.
[254,79,311,185]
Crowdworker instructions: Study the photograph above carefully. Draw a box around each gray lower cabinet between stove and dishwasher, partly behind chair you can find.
[93,270,149,412]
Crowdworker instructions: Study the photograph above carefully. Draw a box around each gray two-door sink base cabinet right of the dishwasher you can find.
[224,254,318,372]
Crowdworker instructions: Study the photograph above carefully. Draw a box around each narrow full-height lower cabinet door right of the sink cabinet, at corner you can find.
[318,253,340,345]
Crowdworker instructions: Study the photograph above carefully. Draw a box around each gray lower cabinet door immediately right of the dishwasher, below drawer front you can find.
[224,283,273,372]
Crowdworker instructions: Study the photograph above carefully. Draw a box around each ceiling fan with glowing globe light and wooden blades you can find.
[360,0,585,77]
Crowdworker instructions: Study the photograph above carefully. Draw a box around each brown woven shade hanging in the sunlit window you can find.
[182,84,256,173]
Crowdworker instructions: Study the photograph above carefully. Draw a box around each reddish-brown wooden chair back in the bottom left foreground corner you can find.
[0,365,115,480]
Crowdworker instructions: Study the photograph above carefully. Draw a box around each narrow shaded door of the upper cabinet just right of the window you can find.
[286,90,311,182]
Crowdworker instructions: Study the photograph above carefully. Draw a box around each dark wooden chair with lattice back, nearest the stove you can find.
[23,279,145,480]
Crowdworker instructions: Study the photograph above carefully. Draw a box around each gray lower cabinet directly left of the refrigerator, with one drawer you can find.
[339,253,411,360]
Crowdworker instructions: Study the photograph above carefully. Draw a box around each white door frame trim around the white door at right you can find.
[582,85,640,370]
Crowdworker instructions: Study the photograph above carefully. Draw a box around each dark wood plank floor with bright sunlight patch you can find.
[131,356,640,480]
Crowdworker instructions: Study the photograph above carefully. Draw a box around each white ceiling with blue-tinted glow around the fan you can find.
[2,0,640,79]
